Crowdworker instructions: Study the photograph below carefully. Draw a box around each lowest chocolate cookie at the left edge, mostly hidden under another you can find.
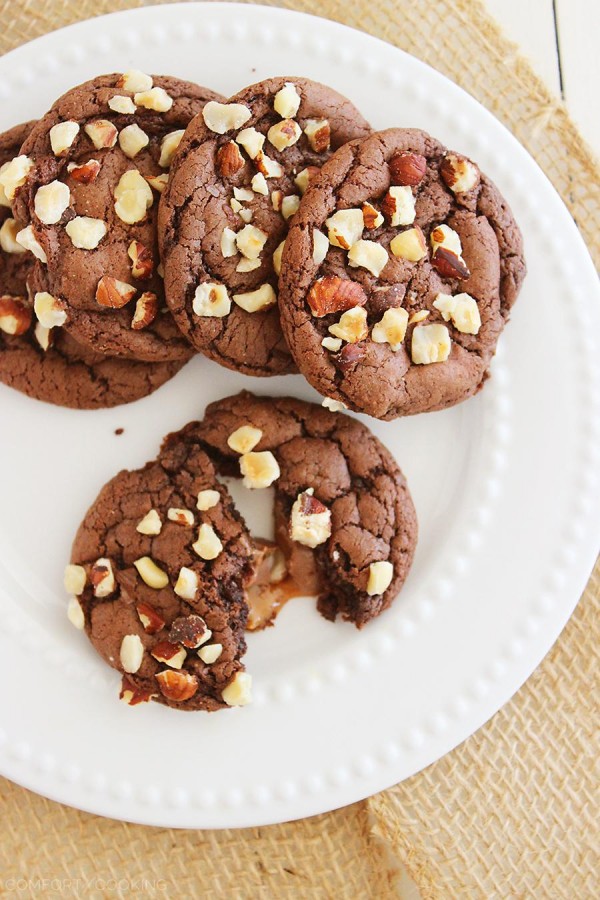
[0,122,184,409]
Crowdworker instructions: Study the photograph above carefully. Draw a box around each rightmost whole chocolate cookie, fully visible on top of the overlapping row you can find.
[280,128,525,419]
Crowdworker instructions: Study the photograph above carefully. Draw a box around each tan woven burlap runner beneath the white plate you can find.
[0,0,600,900]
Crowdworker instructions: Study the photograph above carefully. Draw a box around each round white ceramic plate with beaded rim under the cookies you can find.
[0,3,600,827]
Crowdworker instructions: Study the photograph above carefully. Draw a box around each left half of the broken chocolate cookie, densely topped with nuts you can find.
[65,432,252,710]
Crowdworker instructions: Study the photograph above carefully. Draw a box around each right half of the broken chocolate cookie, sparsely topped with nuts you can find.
[188,391,417,628]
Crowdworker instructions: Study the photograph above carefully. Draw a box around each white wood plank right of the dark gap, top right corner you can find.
[556,0,600,155]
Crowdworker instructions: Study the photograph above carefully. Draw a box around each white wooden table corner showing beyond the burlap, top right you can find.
[485,0,600,156]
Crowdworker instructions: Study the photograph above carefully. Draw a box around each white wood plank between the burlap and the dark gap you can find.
[486,0,564,94]
